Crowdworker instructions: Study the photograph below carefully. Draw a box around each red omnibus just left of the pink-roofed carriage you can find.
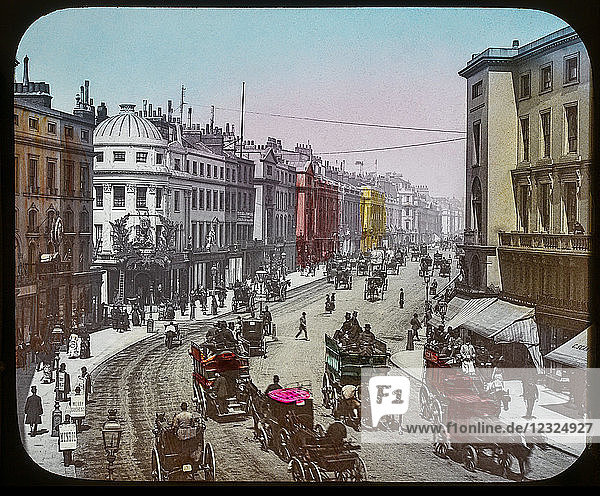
[190,341,250,418]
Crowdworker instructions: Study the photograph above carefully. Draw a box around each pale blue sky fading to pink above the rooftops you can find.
[16,8,567,197]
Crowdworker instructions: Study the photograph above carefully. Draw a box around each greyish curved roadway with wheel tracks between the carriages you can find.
[78,262,575,482]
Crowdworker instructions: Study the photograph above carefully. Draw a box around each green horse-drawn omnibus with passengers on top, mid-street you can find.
[321,334,390,430]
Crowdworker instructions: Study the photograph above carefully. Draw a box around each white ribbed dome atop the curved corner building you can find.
[94,103,166,145]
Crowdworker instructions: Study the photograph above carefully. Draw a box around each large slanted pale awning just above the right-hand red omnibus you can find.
[462,299,538,344]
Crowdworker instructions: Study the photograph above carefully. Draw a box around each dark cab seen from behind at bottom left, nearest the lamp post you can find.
[151,413,215,481]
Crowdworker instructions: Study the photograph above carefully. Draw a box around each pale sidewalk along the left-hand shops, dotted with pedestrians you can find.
[16,270,325,477]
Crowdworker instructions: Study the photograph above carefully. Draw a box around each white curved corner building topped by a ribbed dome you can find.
[94,104,258,305]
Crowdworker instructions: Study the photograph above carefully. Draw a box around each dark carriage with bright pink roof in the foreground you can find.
[251,386,367,482]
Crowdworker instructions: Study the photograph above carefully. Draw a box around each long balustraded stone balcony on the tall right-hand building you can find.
[496,231,592,253]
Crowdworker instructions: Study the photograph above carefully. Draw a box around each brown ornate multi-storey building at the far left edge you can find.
[14,57,101,344]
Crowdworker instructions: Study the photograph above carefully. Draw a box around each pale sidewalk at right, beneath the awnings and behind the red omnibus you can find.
[390,341,585,456]
